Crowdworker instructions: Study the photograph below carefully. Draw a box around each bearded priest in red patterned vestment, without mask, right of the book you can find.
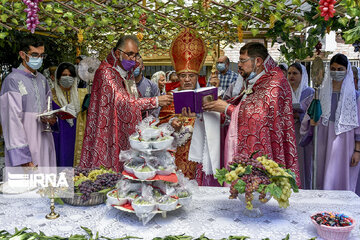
[204,42,300,184]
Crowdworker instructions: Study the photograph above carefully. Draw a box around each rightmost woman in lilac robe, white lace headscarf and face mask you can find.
[301,54,360,191]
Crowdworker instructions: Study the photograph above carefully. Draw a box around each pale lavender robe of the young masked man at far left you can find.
[0,65,56,167]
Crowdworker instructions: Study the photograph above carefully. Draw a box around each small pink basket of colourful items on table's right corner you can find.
[311,212,355,240]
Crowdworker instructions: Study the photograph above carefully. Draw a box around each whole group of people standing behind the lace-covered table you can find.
[0,29,360,194]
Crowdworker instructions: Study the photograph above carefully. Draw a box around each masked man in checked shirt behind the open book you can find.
[207,56,238,97]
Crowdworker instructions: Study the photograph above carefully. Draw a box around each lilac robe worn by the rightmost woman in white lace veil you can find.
[300,92,360,192]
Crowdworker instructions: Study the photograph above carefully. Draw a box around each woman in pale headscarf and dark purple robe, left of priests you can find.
[52,62,87,167]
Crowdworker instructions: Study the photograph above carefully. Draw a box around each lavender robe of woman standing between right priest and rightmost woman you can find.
[295,87,315,189]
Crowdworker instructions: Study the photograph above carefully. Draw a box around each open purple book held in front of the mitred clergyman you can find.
[173,87,218,114]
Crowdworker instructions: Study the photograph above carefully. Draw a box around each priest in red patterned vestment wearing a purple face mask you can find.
[80,35,172,172]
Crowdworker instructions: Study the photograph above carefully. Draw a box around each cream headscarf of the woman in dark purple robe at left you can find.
[54,63,80,127]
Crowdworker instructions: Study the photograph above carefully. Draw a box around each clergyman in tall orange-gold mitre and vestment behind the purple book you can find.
[159,28,207,185]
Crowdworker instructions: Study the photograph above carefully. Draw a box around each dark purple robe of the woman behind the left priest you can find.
[52,101,76,167]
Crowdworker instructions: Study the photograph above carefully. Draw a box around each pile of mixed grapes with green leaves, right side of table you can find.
[215,152,298,210]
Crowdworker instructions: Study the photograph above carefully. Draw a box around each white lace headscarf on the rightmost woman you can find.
[319,56,359,135]
